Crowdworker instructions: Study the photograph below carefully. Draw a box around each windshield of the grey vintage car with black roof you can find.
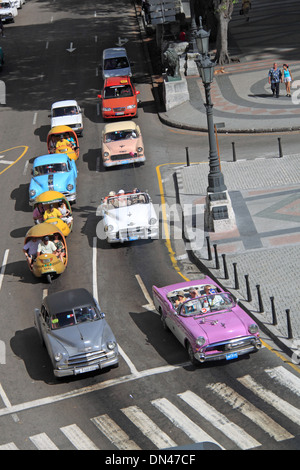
[51,306,101,330]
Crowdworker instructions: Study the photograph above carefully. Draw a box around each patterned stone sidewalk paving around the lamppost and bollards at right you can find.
[135,0,300,363]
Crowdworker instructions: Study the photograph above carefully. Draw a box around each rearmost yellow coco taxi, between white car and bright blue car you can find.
[47,126,79,160]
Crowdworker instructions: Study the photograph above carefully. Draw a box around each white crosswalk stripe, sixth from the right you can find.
[122,406,177,449]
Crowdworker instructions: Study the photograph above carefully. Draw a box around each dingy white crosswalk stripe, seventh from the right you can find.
[91,414,141,450]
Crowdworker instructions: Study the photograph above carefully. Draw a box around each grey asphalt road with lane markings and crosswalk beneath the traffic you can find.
[0,0,299,451]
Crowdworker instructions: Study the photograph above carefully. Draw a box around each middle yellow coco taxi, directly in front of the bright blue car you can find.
[35,191,73,237]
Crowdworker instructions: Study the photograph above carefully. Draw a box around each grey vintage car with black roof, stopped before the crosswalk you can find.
[34,288,118,377]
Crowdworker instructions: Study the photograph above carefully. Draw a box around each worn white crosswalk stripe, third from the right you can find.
[207,382,294,441]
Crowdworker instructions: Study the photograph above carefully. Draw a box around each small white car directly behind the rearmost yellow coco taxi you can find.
[51,100,83,135]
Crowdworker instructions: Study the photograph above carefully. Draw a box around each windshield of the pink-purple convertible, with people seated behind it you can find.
[179,292,236,317]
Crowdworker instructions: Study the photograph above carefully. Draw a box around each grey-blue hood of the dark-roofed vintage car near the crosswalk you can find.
[51,319,107,356]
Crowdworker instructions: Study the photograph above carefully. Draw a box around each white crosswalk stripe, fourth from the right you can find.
[178,390,261,450]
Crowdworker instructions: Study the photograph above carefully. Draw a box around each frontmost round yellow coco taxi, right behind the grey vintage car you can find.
[24,222,68,283]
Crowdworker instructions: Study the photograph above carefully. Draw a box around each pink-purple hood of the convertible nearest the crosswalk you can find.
[181,310,250,343]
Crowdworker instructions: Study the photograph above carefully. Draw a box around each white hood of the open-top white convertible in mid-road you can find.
[104,204,156,229]
